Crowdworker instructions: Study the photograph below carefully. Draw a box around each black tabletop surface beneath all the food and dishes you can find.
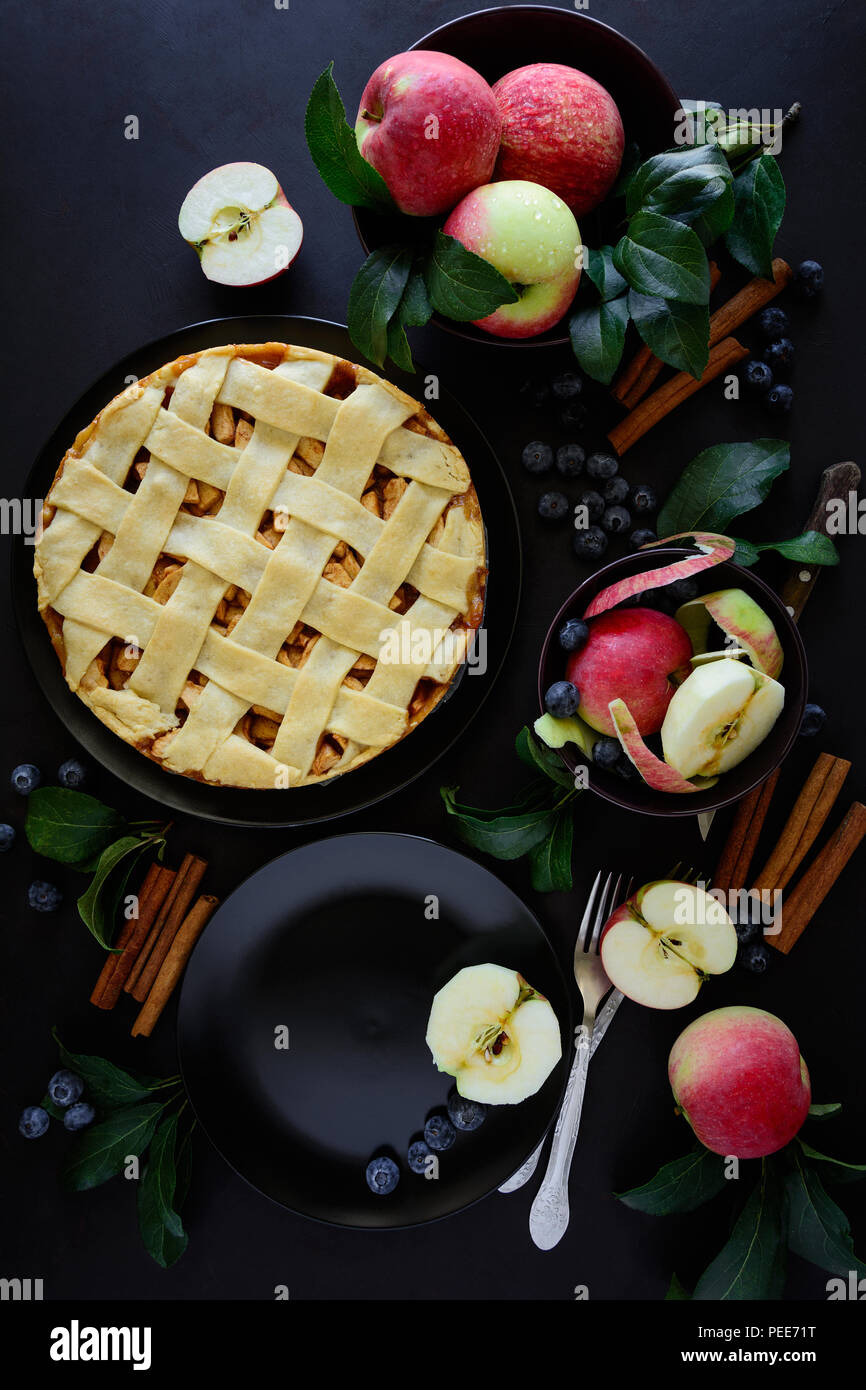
[0,0,866,1300]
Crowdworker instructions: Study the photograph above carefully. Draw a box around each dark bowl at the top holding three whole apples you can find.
[349,4,680,348]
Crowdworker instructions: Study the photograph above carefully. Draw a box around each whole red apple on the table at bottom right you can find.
[667,1005,812,1158]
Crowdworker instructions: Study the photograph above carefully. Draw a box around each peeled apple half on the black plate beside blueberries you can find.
[427,965,562,1105]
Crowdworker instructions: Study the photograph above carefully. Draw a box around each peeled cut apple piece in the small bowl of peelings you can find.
[662,657,785,777]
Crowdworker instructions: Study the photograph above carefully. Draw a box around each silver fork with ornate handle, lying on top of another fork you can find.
[530,873,628,1250]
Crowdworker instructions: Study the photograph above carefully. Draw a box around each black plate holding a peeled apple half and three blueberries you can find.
[178,834,571,1227]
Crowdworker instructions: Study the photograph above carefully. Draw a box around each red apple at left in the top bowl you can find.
[354,50,502,217]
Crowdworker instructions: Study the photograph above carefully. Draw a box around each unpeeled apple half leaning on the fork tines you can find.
[601,878,737,1009]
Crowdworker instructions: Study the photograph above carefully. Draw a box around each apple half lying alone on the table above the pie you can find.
[178,163,303,285]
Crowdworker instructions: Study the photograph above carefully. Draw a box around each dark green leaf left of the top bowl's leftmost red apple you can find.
[304,63,393,213]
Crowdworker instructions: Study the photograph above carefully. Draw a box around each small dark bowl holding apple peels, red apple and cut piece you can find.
[538,546,809,816]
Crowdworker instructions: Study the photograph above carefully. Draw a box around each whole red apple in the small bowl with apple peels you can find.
[566,607,692,737]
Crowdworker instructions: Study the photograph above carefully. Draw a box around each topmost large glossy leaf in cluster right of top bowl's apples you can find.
[626,143,733,221]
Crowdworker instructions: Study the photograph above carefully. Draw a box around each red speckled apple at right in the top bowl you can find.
[493,63,626,217]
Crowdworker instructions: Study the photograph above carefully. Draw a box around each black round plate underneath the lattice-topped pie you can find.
[13,314,521,826]
